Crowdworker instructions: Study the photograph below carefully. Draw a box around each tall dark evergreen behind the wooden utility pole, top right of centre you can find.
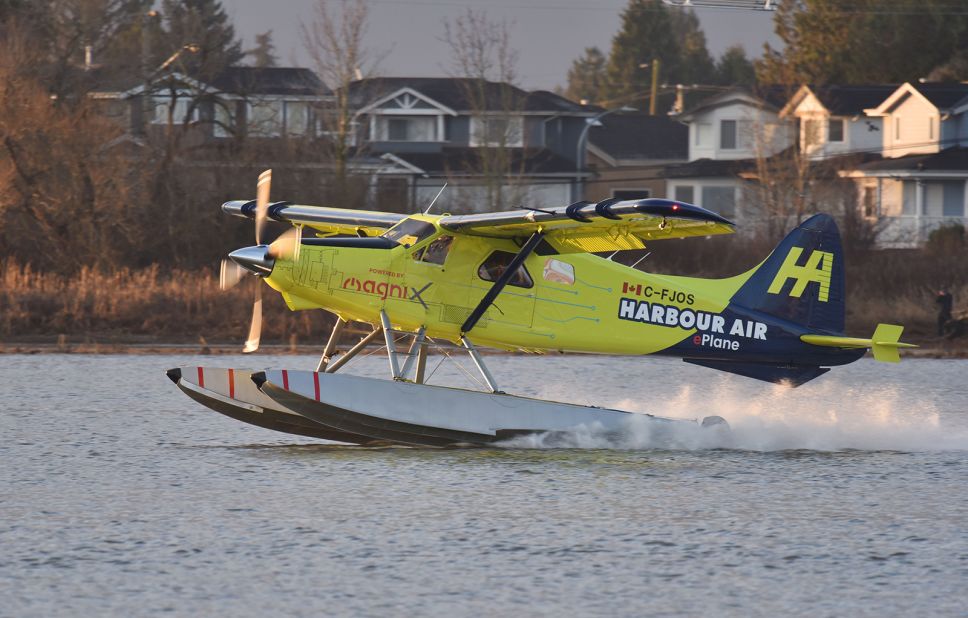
[607,0,715,103]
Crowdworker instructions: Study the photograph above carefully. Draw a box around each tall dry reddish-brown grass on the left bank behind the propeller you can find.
[0,262,332,343]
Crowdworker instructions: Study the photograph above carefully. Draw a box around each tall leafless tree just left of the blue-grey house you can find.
[300,0,380,205]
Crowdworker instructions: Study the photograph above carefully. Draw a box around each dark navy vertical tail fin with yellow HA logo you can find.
[732,214,844,333]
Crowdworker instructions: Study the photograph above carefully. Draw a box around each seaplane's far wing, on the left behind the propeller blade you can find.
[222,200,406,236]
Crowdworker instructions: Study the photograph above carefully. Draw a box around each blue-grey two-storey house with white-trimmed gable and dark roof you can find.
[350,77,595,212]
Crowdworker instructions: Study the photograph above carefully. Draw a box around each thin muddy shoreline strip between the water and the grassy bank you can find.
[0,340,968,360]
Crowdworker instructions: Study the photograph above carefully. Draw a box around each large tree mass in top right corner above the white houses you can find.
[757,0,968,84]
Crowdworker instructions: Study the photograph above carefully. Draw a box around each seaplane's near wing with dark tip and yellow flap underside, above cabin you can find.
[440,199,735,253]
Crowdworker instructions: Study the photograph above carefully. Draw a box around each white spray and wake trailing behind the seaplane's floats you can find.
[503,381,968,451]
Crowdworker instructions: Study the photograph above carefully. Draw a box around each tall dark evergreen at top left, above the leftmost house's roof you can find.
[158,0,244,80]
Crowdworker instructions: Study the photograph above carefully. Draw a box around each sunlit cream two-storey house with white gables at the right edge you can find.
[840,83,968,247]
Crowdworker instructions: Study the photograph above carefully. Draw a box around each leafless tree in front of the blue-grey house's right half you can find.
[443,9,526,210]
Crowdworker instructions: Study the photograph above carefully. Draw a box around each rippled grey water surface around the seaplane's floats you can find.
[0,355,968,616]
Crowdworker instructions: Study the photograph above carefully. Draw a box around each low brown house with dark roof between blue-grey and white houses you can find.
[583,113,689,202]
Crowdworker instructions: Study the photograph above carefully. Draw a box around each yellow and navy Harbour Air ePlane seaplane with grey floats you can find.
[168,171,912,446]
